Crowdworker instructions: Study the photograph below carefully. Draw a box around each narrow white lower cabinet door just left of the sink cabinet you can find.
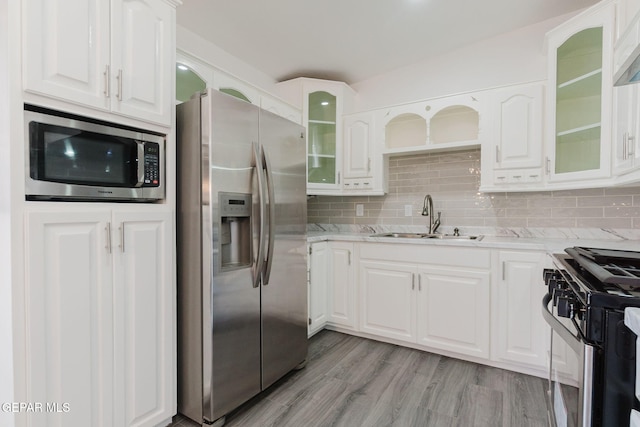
[327,242,356,329]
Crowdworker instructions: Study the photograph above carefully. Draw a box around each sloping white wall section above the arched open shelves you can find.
[351,13,575,111]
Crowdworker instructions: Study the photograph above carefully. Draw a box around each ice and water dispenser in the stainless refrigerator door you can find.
[218,193,251,270]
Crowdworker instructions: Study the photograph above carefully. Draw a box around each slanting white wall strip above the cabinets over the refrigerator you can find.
[176,26,276,98]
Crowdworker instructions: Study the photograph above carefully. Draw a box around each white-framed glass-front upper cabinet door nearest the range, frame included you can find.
[546,2,614,186]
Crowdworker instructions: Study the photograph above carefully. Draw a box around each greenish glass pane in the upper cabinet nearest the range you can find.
[554,27,603,174]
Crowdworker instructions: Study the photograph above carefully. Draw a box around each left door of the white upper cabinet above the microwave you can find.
[22,0,109,109]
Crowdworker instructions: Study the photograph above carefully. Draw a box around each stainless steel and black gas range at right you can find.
[542,247,640,427]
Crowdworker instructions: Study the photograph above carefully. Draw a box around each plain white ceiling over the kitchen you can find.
[177,0,597,84]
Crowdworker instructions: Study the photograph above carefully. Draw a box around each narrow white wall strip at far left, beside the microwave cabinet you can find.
[0,1,19,426]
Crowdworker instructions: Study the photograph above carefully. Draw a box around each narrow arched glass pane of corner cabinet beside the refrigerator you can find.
[307,91,337,185]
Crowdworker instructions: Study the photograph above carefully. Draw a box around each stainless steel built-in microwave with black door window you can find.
[24,105,165,202]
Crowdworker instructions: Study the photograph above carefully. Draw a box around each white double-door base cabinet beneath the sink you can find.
[359,244,491,358]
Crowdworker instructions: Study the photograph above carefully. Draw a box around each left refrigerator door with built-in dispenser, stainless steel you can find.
[202,90,261,421]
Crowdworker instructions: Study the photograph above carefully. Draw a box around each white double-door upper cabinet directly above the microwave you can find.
[23,0,175,125]
